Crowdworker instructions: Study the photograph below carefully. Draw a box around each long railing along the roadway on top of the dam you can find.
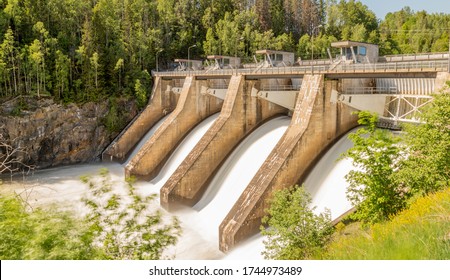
[153,60,449,77]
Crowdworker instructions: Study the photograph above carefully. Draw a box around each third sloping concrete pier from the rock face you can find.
[160,76,288,208]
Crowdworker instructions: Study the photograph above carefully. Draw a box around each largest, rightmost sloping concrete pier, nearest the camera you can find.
[219,75,357,252]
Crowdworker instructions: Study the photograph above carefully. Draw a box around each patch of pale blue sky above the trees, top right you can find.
[359,0,450,19]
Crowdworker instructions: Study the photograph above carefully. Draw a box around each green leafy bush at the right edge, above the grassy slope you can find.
[396,87,450,195]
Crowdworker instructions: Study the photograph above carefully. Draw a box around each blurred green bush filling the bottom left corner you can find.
[0,196,99,260]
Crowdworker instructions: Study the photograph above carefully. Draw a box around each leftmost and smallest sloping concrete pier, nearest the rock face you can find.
[102,77,178,162]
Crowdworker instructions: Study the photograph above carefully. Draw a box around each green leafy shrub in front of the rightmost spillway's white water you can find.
[343,112,408,223]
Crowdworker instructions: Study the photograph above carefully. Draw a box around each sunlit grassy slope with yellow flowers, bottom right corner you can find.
[320,188,450,260]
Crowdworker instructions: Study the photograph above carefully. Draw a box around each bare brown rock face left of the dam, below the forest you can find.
[0,98,137,169]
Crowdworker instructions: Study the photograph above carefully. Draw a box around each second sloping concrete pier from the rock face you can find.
[125,77,223,180]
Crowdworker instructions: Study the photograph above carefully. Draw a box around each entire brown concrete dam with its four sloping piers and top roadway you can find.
[103,42,450,252]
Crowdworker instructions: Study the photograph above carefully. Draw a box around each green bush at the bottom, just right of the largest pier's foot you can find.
[261,186,332,260]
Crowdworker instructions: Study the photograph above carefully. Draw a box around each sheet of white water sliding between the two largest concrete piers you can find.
[193,117,290,243]
